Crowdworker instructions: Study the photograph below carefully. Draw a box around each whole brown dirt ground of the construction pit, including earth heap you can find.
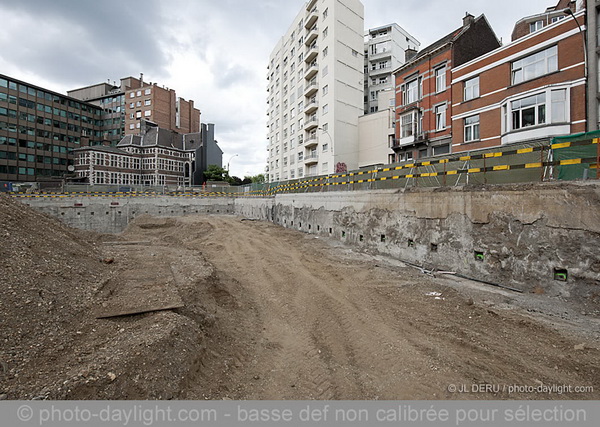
[0,196,600,400]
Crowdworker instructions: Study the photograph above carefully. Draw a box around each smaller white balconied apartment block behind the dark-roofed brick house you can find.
[364,23,421,114]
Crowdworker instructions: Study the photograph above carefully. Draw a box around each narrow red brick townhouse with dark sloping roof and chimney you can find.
[392,14,500,161]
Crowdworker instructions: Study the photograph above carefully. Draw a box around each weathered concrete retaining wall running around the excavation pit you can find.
[18,182,600,307]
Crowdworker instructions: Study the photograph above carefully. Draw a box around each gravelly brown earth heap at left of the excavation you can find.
[0,195,219,400]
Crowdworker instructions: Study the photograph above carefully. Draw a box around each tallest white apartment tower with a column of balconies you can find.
[267,0,364,182]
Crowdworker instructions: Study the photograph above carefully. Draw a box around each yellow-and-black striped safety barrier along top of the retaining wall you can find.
[9,136,600,198]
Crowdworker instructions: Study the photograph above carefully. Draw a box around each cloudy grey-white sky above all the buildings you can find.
[0,0,557,177]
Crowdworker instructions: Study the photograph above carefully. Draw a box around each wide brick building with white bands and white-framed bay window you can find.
[452,7,586,152]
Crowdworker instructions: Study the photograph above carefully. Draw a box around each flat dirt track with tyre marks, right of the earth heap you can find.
[123,216,600,399]
